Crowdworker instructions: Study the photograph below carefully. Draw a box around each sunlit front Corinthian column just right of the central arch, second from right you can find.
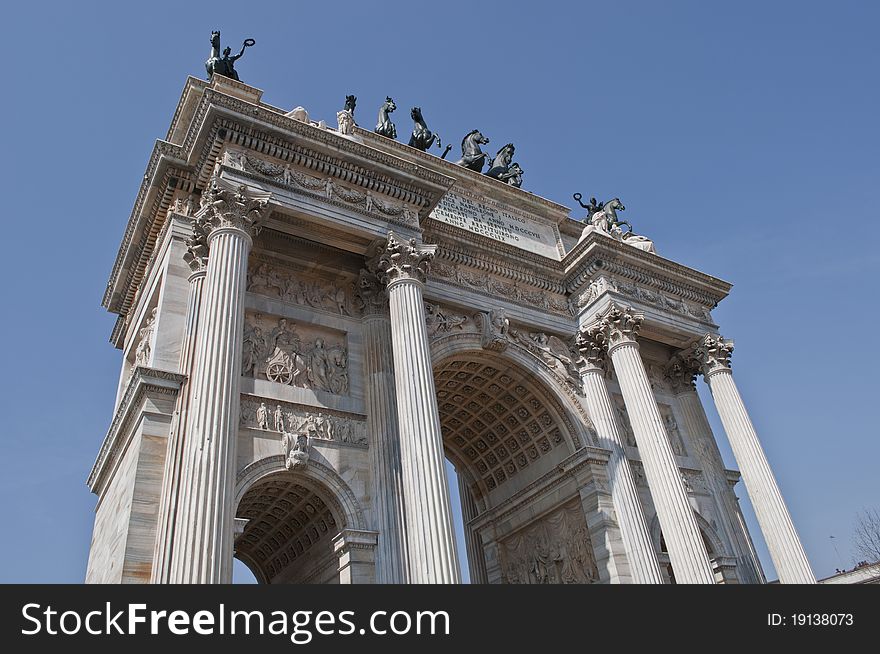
[587,304,715,584]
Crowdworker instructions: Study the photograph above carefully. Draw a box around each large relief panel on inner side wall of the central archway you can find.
[501,500,599,584]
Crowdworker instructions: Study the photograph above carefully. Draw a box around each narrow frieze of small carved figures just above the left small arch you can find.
[239,395,367,445]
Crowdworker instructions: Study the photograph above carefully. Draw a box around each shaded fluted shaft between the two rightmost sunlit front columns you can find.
[676,383,763,584]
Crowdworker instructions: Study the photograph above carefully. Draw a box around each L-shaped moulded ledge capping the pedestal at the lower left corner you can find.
[86,366,186,494]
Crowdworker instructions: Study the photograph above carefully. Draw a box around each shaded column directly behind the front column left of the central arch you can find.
[357,270,408,584]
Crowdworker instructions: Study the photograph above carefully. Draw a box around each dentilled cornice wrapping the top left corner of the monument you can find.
[102,78,455,326]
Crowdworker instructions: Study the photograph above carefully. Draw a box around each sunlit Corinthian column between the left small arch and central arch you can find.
[377,233,460,584]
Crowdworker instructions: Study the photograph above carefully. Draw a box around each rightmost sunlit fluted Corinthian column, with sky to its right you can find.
[687,334,816,584]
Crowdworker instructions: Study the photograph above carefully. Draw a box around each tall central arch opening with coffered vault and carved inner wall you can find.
[434,350,597,583]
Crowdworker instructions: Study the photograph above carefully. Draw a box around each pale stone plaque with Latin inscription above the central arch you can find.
[431,193,561,261]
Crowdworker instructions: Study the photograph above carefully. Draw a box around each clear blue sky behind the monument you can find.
[0,1,880,582]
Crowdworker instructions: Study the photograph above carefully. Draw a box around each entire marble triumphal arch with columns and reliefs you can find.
[87,69,814,584]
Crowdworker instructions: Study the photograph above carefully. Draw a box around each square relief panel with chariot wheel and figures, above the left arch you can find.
[241,312,349,395]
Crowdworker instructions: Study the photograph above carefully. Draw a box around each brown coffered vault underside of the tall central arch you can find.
[432,333,595,509]
